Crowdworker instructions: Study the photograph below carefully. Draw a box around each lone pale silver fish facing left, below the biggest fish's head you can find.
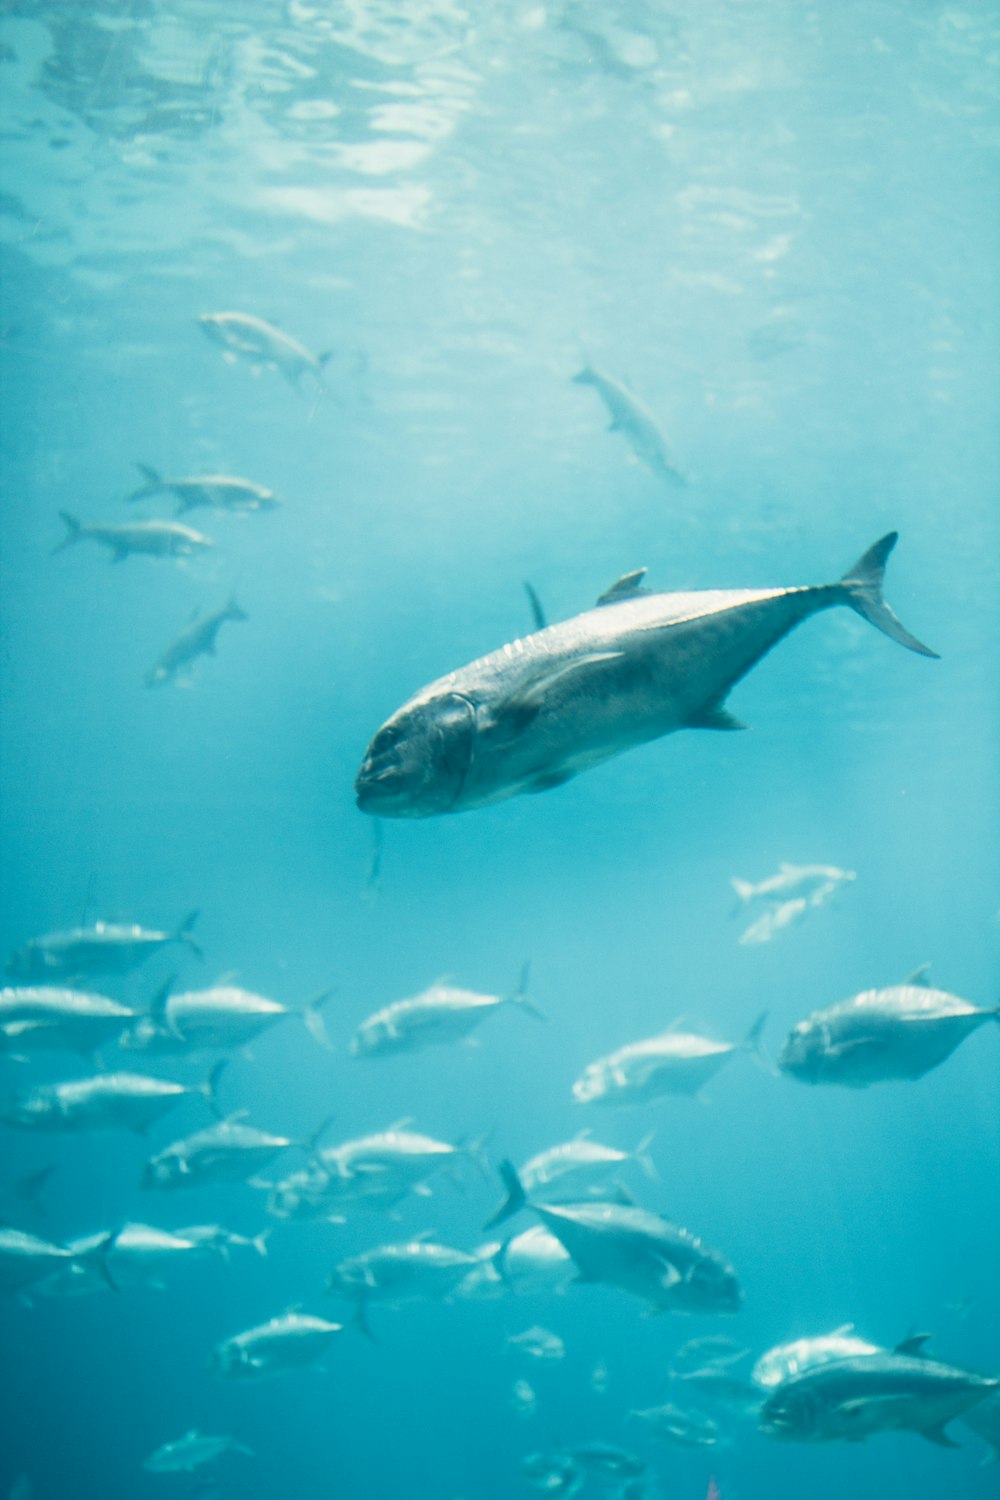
[351,965,544,1058]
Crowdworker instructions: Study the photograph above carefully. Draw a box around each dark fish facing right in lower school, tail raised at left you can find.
[490,1161,744,1313]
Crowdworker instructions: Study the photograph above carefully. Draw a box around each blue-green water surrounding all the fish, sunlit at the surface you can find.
[0,0,1000,1500]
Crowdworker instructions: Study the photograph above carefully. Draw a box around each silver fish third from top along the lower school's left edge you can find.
[0,1064,223,1133]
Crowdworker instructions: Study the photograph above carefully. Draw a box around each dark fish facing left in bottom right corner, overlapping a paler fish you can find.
[760,1352,1000,1448]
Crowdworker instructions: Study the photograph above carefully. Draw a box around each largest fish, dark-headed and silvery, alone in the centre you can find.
[355,531,937,818]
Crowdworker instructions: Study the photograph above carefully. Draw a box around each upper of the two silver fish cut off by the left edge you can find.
[0,984,138,1055]
